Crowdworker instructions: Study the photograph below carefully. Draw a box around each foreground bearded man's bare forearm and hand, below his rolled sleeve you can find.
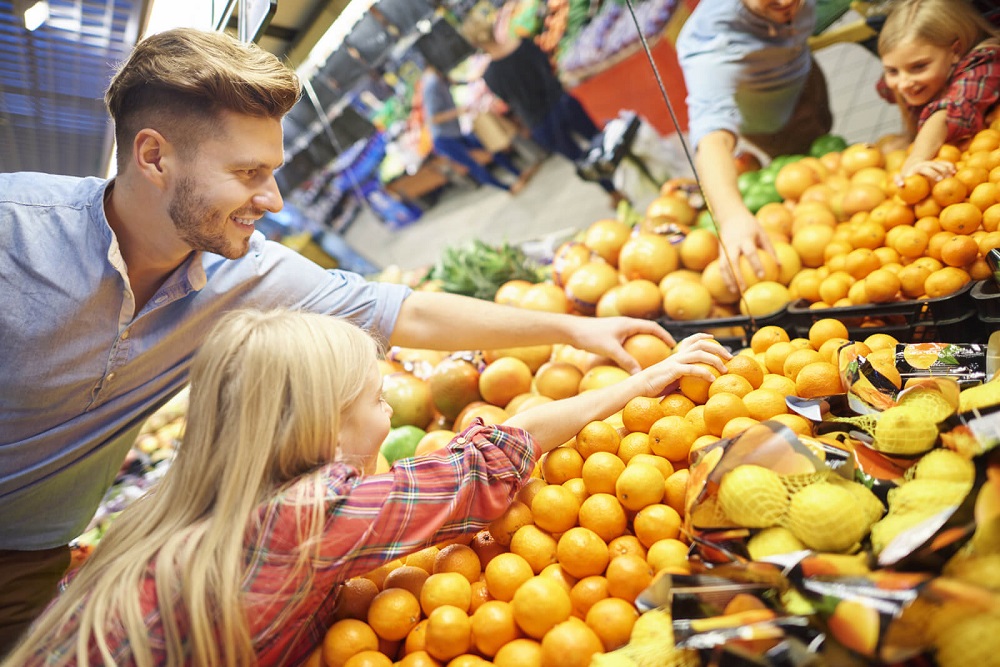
[389,292,674,373]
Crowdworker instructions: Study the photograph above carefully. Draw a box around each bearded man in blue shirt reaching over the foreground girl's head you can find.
[0,29,670,655]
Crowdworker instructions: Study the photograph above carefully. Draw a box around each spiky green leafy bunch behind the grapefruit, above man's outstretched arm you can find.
[426,240,542,301]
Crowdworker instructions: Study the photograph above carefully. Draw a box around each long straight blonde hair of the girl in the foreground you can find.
[9,311,378,667]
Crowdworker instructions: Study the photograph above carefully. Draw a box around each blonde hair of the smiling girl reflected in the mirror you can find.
[878,0,1000,137]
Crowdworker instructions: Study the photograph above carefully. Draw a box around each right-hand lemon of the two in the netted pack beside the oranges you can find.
[785,482,871,551]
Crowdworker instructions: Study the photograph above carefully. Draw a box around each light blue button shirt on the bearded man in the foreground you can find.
[0,173,410,550]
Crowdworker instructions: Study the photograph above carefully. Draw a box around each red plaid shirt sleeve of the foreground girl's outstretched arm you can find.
[254,422,540,581]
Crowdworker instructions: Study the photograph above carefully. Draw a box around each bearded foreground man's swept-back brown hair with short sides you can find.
[104,28,302,171]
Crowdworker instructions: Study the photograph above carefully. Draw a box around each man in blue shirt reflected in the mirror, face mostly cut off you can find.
[677,0,833,288]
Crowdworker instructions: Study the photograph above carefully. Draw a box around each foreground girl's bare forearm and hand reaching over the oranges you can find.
[504,334,731,452]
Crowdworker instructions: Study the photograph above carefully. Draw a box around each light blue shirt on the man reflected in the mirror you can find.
[677,0,816,148]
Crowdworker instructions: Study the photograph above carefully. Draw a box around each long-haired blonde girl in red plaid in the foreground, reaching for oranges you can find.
[4,310,728,667]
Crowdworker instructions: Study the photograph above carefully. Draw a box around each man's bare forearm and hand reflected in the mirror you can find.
[695,130,774,290]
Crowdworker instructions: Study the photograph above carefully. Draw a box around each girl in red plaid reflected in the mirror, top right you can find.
[877,0,1000,181]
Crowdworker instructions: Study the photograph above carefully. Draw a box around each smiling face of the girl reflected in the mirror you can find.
[882,39,959,106]
